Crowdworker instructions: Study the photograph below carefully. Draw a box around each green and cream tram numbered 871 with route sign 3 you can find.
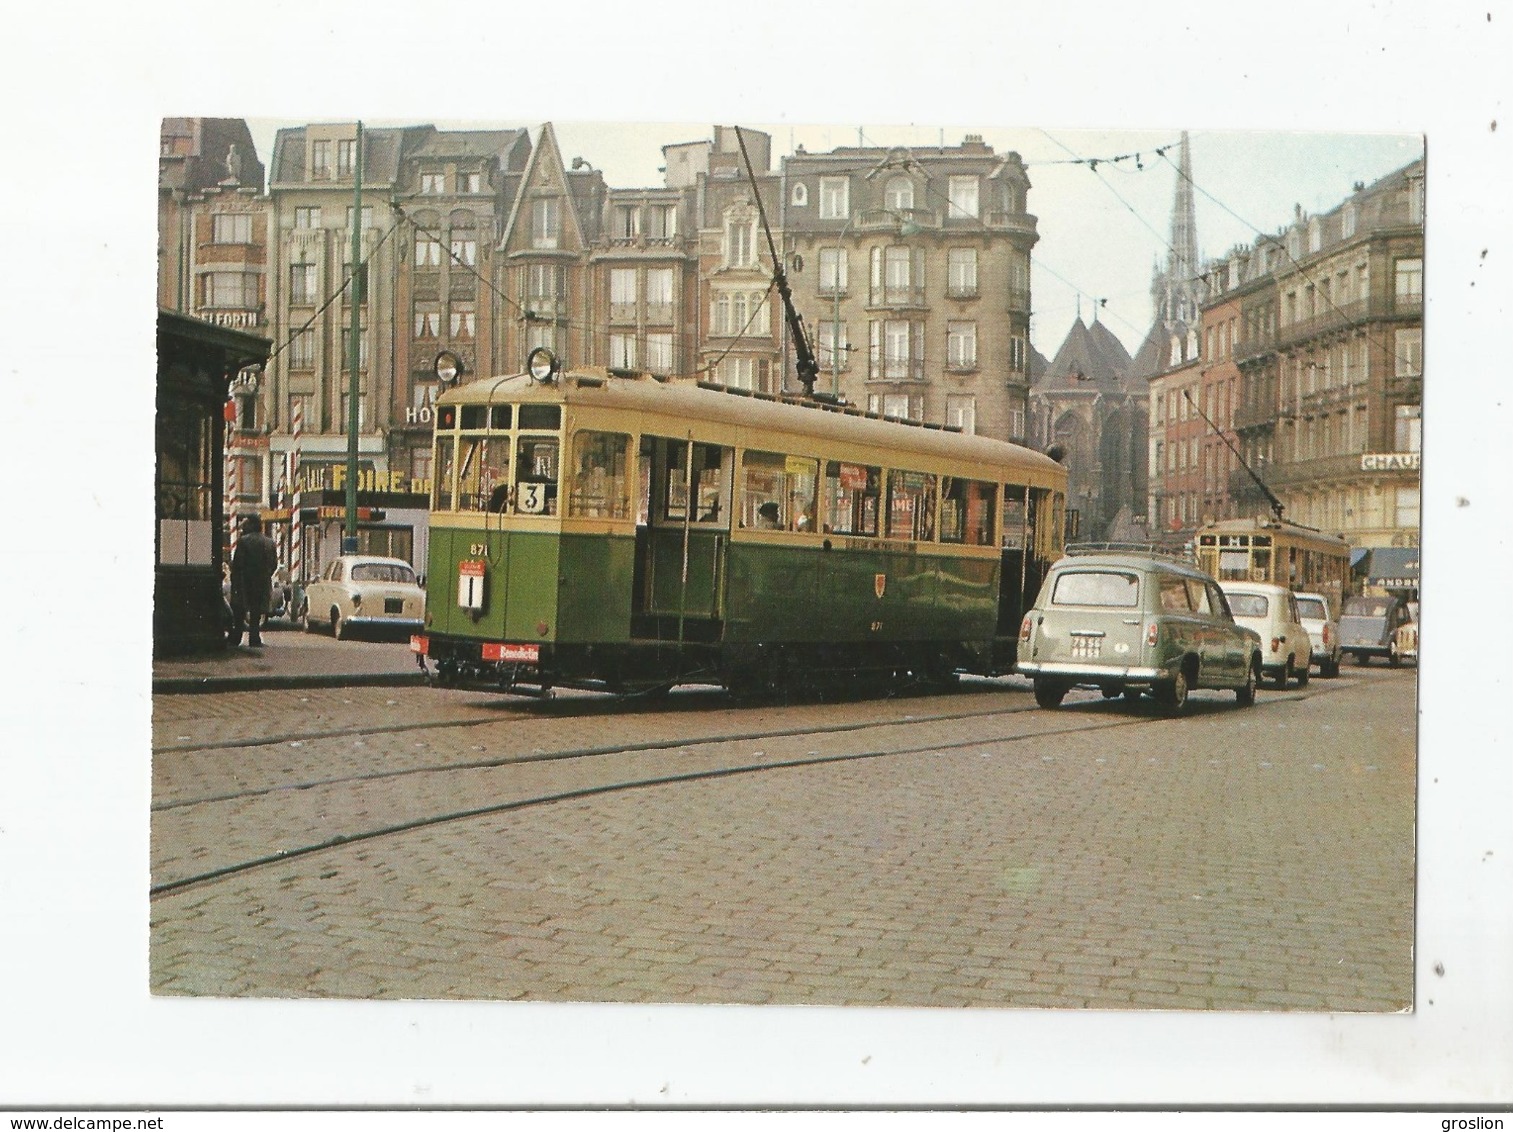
[412,351,1067,695]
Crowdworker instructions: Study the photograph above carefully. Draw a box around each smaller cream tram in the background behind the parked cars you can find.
[1195,518,1351,614]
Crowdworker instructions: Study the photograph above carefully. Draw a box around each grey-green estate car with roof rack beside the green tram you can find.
[1015,548,1262,714]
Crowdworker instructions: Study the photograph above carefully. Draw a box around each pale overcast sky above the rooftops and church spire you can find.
[250,118,1424,357]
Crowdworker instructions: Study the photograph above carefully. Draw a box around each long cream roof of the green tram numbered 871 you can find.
[437,369,1065,474]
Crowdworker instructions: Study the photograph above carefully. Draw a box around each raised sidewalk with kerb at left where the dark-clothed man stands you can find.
[153,622,425,693]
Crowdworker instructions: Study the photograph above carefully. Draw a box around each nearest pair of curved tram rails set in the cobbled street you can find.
[148,696,1298,900]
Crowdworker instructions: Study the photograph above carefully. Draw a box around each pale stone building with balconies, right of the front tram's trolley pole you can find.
[780,127,1038,440]
